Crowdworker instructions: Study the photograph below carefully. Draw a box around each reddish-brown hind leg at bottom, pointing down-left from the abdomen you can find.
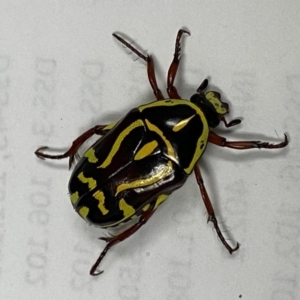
[90,202,155,276]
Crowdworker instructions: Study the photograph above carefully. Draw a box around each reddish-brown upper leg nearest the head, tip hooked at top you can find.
[167,29,190,99]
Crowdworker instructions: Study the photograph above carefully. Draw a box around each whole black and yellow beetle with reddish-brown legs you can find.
[35,30,288,275]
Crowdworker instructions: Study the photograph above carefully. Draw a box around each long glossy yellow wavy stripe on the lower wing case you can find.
[115,161,172,196]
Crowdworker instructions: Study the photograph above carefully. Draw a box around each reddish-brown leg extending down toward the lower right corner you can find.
[194,165,239,254]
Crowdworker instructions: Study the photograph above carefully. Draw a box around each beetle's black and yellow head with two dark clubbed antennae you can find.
[190,79,241,128]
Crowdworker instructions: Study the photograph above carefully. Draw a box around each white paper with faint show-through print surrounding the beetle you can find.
[0,0,300,300]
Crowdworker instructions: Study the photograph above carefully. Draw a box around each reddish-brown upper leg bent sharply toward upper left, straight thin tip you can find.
[113,33,165,100]
